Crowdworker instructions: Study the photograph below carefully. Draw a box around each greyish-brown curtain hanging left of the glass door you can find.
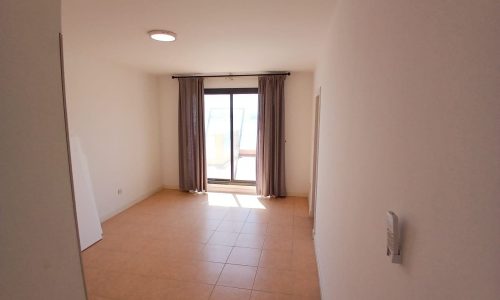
[179,78,207,192]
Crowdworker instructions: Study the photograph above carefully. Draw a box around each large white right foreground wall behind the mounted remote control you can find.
[315,0,500,300]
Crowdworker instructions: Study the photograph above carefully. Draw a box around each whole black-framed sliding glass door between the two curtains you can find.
[205,88,258,184]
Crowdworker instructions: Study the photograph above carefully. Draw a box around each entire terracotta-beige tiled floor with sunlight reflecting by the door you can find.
[82,190,320,300]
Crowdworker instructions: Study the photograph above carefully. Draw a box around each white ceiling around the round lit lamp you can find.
[62,0,334,74]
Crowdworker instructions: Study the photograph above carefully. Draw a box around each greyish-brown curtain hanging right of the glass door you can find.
[256,75,286,197]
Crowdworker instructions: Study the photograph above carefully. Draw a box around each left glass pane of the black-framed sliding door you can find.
[205,94,231,181]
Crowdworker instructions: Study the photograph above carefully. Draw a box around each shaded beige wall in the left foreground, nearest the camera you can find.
[0,0,85,300]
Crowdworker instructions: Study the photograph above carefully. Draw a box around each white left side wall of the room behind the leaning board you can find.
[65,48,162,221]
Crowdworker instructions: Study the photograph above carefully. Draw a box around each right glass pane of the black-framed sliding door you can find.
[233,94,259,181]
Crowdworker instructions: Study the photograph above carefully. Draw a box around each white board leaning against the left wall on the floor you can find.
[69,136,102,251]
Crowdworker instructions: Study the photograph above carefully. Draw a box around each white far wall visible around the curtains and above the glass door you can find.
[159,72,313,196]
